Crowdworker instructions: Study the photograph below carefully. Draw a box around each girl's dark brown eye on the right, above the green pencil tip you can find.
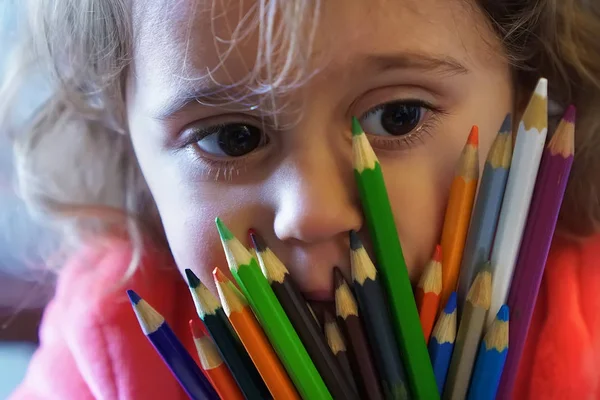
[360,100,429,136]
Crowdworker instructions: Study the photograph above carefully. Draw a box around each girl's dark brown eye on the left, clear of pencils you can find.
[196,123,266,157]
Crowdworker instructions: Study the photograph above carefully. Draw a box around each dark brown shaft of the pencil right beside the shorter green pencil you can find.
[271,274,358,399]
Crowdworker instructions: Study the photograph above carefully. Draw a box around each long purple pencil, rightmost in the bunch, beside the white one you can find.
[500,106,575,397]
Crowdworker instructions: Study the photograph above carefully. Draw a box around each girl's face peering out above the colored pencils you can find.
[127,0,513,301]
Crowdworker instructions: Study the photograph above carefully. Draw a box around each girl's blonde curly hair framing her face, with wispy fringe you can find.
[0,0,600,268]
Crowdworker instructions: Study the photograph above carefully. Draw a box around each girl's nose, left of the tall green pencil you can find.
[274,139,362,244]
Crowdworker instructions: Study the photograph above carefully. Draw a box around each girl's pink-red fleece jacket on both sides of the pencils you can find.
[12,236,600,400]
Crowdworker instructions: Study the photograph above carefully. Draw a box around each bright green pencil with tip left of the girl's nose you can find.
[215,218,332,399]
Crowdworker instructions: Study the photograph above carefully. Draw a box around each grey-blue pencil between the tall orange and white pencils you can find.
[458,114,512,315]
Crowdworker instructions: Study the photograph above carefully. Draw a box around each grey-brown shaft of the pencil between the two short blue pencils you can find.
[443,302,487,400]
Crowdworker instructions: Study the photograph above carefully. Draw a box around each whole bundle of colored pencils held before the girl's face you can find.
[129,79,575,400]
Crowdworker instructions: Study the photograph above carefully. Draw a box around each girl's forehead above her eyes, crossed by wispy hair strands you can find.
[131,0,501,119]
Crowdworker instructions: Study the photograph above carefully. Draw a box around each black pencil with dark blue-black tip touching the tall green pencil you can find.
[350,231,409,400]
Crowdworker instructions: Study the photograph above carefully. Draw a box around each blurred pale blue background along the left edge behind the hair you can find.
[0,0,54,399]
